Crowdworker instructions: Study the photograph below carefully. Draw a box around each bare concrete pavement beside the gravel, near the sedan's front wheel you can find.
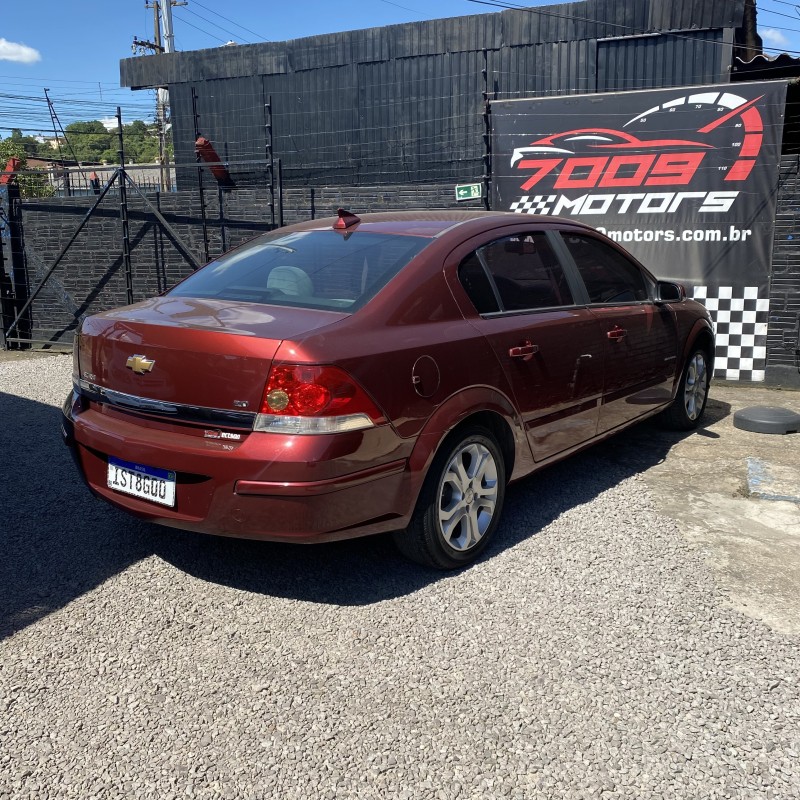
[629,383,800,634]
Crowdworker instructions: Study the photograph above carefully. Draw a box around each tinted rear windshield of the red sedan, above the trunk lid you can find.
[170,231,432,311]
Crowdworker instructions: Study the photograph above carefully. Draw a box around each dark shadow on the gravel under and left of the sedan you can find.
[0,392,730,638]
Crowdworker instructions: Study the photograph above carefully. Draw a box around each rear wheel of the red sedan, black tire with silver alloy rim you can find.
[394,426,506,570]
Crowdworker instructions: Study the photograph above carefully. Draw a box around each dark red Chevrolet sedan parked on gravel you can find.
[63,211,714,569]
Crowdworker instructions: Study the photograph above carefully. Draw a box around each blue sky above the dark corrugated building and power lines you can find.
[0,0,800,137]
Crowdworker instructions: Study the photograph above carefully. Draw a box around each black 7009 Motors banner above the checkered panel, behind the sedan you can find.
[492,81,786,297]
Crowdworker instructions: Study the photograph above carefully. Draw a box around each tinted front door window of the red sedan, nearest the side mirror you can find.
[562,233,649,303]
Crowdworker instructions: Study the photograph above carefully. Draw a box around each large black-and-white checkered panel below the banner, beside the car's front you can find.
[694,286,769,381]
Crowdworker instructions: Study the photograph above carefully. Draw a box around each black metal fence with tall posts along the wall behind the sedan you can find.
[0,79,491,348]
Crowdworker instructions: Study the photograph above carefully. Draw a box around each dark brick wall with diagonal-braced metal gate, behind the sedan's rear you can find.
[0,172,481,348]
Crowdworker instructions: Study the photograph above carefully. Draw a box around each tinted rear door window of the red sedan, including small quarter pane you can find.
[459,233,574,314]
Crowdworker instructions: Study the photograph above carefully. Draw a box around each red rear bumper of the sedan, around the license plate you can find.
[62,394,417,543]
